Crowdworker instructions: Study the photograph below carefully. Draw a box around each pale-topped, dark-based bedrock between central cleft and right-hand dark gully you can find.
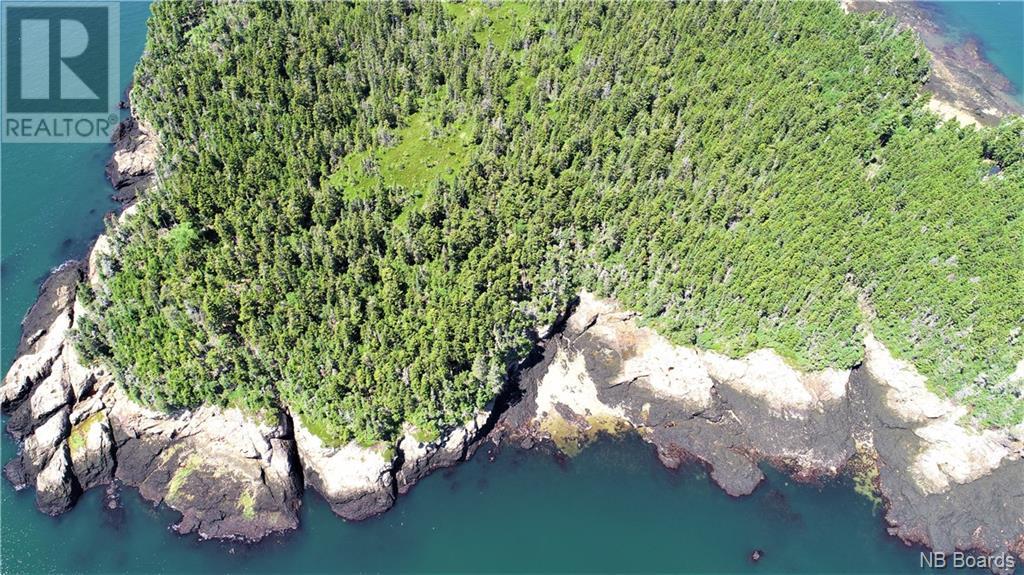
[512,286,852,482]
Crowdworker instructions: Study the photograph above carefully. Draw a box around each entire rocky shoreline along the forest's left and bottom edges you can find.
[0,109,1024,562]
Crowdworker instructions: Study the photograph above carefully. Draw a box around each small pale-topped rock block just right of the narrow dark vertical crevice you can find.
[294,419,394,521]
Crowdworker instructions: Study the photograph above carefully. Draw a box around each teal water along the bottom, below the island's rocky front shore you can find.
[3,438,950,573]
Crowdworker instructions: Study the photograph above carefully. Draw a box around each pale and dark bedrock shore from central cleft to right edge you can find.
[495,294,1024,560]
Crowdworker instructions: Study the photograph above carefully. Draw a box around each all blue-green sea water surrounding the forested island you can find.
[0,2,1024,573]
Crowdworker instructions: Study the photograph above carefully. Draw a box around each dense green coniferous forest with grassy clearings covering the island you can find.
[78,1,1024,444]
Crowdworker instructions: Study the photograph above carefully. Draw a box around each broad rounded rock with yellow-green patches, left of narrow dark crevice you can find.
[104,387,302,539]
